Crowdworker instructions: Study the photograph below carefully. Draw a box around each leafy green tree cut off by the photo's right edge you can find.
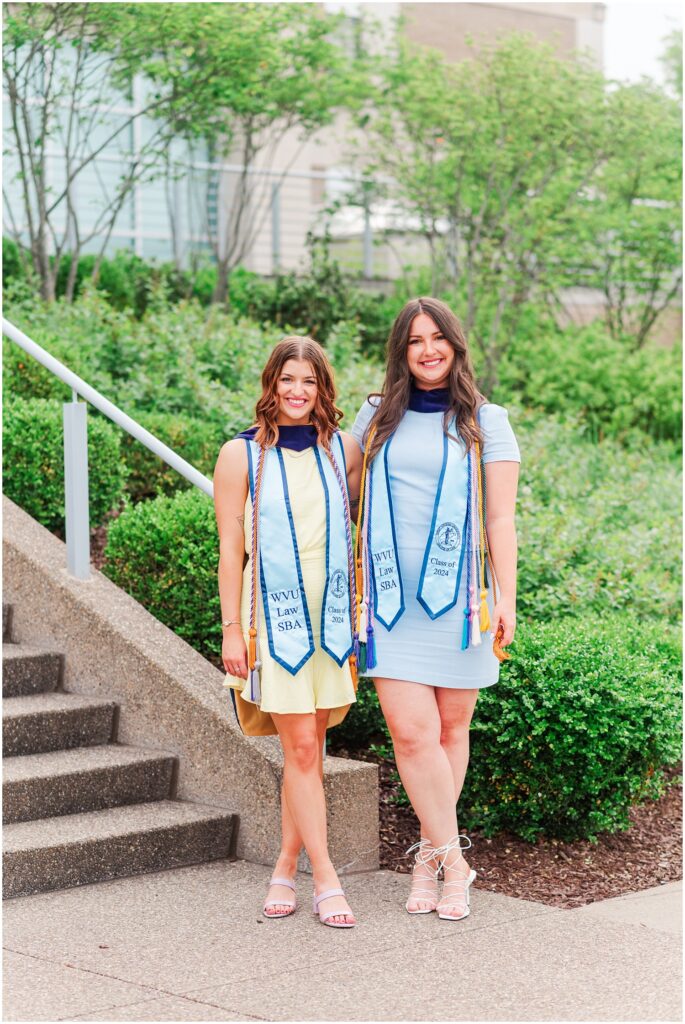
[567,80,682,348]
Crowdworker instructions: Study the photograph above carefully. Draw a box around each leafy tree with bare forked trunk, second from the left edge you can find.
[98,3,363,301]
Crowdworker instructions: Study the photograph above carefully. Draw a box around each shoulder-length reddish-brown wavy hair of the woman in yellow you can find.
[250,335,343,449]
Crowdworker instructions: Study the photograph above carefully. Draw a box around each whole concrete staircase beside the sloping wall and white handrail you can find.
[2,604,237,897]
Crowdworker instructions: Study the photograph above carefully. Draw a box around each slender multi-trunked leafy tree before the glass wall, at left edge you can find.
[3,3,187,301]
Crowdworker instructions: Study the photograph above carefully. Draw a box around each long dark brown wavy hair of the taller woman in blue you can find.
[369,297,485,459]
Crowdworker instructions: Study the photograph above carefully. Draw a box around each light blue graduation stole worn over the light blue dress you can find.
[368,420,469,630]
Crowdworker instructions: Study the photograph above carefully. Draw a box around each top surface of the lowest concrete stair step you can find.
[3,800,233,853]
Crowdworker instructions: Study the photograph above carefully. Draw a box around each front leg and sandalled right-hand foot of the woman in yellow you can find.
[272,710,354,924]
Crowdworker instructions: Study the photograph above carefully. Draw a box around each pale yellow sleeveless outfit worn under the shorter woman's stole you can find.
[225,447,355,731]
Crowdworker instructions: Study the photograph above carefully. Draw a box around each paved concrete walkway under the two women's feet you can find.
[4,861,681,1021]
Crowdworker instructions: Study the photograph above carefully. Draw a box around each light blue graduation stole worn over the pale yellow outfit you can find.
[246,434,352,676]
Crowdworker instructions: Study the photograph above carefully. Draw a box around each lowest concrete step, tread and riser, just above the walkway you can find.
[3,800,237,897]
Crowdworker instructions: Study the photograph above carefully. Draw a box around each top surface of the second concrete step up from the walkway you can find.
[2,743,174,782]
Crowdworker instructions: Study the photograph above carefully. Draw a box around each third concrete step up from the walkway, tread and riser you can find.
[2,693,117,757]
